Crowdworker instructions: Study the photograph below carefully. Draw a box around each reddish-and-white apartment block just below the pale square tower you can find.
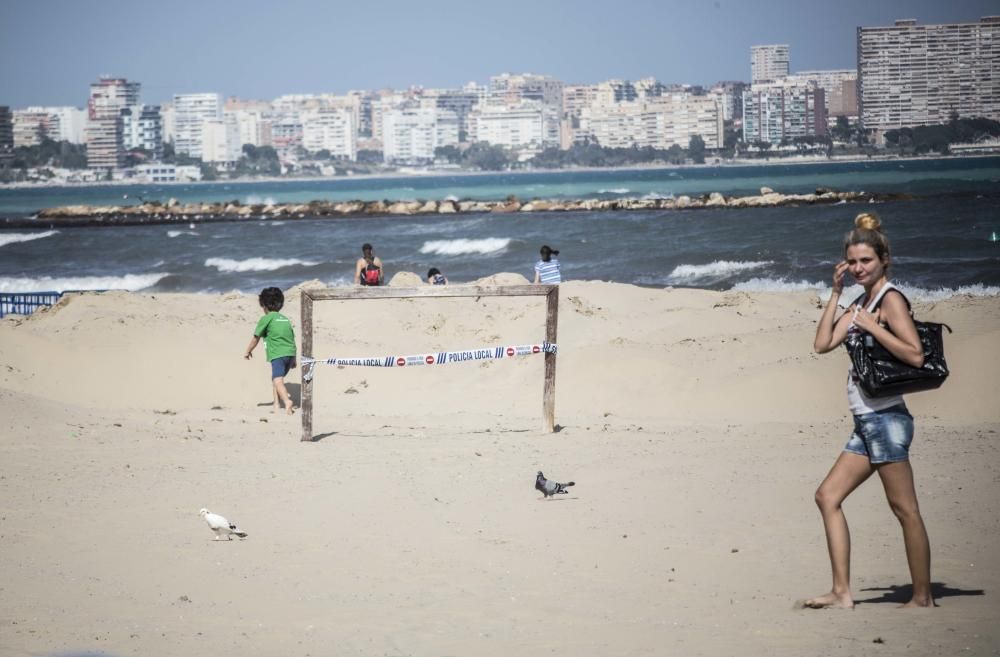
[743,82,827,144]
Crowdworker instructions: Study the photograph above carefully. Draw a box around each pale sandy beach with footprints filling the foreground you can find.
[0,274,1000,657]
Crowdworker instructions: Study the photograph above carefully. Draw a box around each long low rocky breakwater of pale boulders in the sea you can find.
[17,187,909,226]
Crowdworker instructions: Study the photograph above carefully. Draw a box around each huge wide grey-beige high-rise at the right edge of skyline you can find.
[858,16,1000,131]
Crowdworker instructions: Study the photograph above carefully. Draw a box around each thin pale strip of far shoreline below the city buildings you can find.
[0,149,1000,190]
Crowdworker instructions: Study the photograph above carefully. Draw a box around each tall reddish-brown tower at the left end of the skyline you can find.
[86,78,139,169]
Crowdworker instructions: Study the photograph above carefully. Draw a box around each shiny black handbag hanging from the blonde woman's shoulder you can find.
[849,288,951,397]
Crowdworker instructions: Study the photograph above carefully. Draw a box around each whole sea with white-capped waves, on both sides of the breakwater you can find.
[0,157,1000,301]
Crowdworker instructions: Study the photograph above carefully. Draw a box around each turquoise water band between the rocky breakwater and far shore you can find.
[0,157,1000,216]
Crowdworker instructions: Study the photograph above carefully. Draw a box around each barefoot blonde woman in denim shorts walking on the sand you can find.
[804,213,934,609]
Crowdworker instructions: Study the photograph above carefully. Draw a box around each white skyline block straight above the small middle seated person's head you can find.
[382,107,459,164]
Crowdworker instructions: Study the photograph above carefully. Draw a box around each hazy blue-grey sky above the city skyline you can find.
[0,0,1000,108]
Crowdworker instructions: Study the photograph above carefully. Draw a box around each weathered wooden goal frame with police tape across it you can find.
[301,285,559,442]
